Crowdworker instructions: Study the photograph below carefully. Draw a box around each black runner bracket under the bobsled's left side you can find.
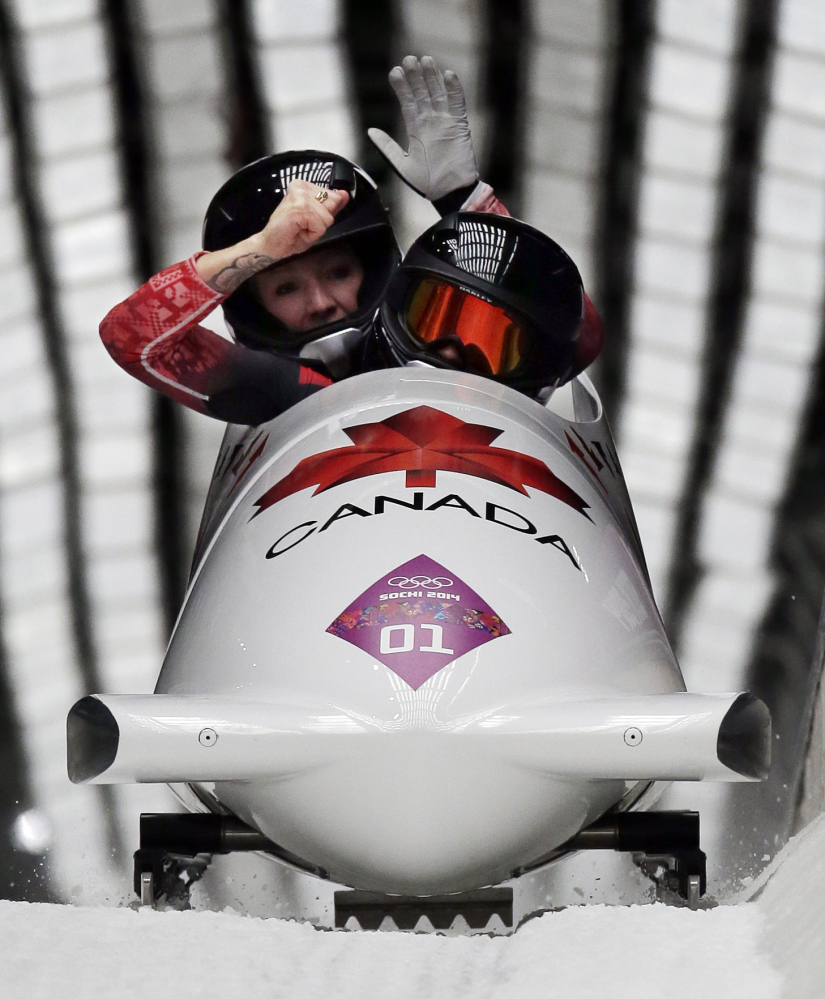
[135,812,329,908]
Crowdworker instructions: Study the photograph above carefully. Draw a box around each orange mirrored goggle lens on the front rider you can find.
[404,278,527,375]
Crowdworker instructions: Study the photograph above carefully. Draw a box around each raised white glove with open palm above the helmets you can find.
[367,56,478,201]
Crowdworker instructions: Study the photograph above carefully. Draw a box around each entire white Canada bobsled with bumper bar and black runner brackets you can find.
[68,367,770,920]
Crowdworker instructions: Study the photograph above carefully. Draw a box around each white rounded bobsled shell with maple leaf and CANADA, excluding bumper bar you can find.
[150,369,688,894]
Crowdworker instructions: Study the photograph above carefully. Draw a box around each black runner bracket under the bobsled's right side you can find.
[513,812,707,909]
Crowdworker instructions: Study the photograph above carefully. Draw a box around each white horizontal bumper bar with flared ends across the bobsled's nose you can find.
[67,693,771,784]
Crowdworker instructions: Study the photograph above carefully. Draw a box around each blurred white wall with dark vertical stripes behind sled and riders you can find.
[0,0,825,902]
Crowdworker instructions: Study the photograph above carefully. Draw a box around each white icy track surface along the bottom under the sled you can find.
[0,816,825,999]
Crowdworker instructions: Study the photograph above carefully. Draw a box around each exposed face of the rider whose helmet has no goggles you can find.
[253,246,364,333]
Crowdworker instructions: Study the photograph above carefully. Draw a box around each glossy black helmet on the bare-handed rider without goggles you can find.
[203,149,401,374]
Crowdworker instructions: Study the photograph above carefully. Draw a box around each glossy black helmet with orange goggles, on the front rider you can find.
[376,212,595,395]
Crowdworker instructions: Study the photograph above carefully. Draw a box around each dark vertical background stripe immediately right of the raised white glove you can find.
[478,0,530,216]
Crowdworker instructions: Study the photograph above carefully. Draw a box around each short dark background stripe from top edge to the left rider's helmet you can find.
[218,0,273,167]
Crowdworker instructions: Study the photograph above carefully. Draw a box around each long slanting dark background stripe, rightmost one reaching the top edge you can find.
[664,0,779,648]
